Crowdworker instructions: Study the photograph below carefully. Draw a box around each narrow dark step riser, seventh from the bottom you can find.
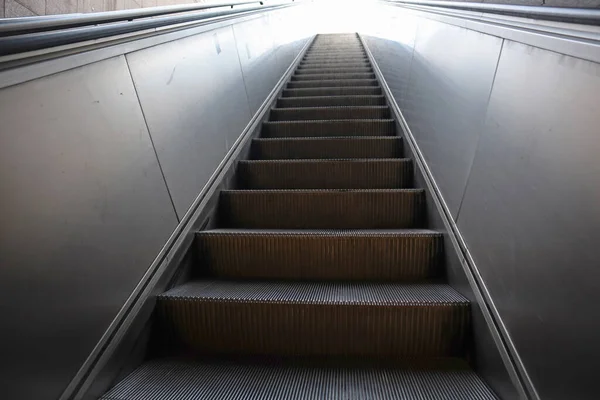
[270,106,390,121]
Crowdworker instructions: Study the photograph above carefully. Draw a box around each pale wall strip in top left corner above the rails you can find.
[0,0,211,18]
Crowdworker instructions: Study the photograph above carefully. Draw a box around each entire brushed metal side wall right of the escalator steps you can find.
[365,3,600,400]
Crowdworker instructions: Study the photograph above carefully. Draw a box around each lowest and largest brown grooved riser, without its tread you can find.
[158,297,469,358]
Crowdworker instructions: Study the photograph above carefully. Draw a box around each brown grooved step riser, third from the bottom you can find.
[219,189,425,229]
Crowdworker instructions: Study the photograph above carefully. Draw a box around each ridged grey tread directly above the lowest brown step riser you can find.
[158,280,470,307]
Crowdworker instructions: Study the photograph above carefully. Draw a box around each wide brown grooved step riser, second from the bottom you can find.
[196,229,443,282]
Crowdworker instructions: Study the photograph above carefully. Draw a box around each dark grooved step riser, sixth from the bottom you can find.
[262,119,396,137]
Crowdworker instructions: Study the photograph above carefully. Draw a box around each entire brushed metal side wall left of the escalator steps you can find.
[0,7,309,399]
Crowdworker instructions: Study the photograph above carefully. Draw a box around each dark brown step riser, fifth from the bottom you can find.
[252,136,403,160]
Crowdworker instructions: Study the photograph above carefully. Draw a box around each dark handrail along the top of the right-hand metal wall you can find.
[382,0,600,25]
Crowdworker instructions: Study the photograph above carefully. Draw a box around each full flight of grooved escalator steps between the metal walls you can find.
[102,34,496,400]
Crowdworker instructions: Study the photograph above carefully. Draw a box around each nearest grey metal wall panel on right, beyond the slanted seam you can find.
[458,42,600,399]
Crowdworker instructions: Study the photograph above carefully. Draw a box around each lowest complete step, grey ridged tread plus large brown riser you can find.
[157,280,470,358]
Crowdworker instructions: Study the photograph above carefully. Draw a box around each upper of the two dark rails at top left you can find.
[0,0,264,36]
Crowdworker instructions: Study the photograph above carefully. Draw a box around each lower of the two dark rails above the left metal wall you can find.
[0,0,294,56]
